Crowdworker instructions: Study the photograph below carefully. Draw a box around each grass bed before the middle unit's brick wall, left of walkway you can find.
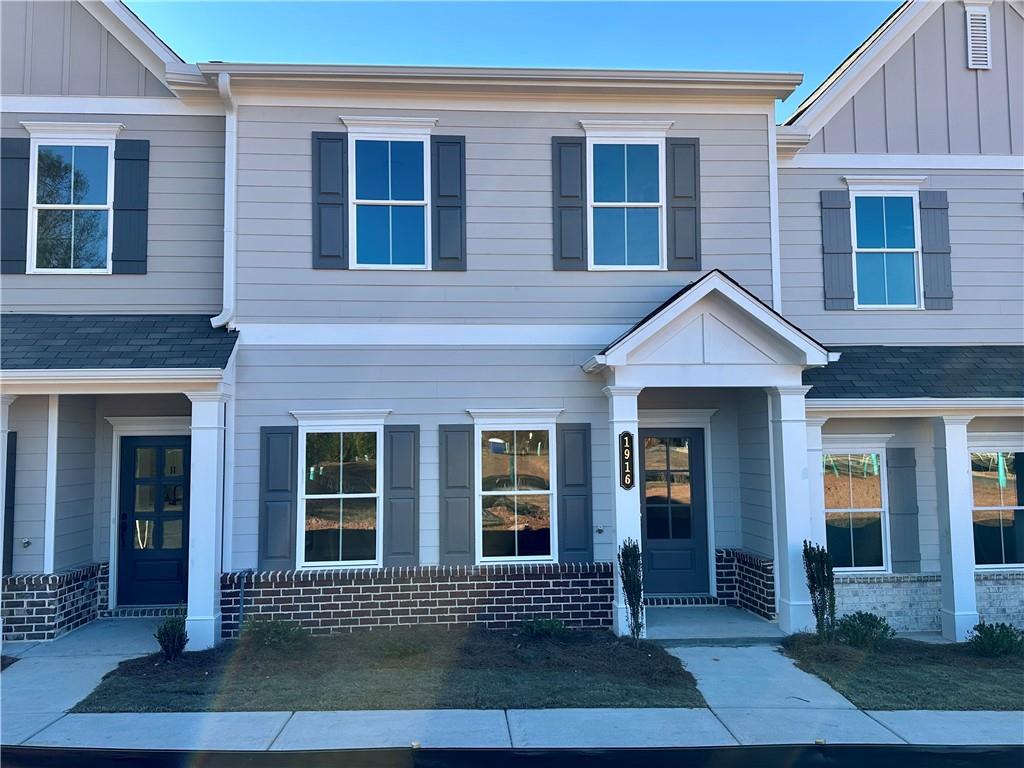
[74,627,705,712]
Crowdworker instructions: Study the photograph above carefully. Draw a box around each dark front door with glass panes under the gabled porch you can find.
[640,429,710,595]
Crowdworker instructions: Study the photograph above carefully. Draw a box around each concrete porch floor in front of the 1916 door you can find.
[647,605,785,644]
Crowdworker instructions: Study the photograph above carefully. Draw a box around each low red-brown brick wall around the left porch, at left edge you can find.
[0,565,99,641]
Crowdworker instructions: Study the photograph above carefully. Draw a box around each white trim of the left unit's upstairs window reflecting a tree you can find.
[22,122,124,274]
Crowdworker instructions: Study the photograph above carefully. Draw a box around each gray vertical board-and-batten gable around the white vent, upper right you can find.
[807,2,1024,155]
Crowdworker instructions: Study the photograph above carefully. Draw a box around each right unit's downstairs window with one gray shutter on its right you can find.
[821,449,889,570]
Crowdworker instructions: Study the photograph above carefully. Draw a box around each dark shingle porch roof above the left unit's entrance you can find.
[0,314,238,371]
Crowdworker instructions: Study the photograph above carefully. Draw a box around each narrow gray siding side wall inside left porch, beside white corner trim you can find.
[53,395,96,570]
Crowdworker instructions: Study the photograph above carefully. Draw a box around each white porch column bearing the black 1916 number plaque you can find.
[604,386,642,636]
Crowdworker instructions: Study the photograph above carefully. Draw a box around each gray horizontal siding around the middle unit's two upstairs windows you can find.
[237,105,771,324]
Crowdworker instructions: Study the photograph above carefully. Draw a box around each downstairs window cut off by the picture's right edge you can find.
[971,450,1024,566]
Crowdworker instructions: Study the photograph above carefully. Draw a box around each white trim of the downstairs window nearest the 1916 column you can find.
[467,409,562,565]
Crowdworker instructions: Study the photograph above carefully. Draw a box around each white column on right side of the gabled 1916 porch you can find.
[768,386,814,633]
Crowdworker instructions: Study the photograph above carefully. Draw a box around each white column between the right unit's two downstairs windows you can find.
[934,416,978,641]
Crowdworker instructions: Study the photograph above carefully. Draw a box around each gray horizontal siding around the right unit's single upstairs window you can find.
[778,169,1024,344]
